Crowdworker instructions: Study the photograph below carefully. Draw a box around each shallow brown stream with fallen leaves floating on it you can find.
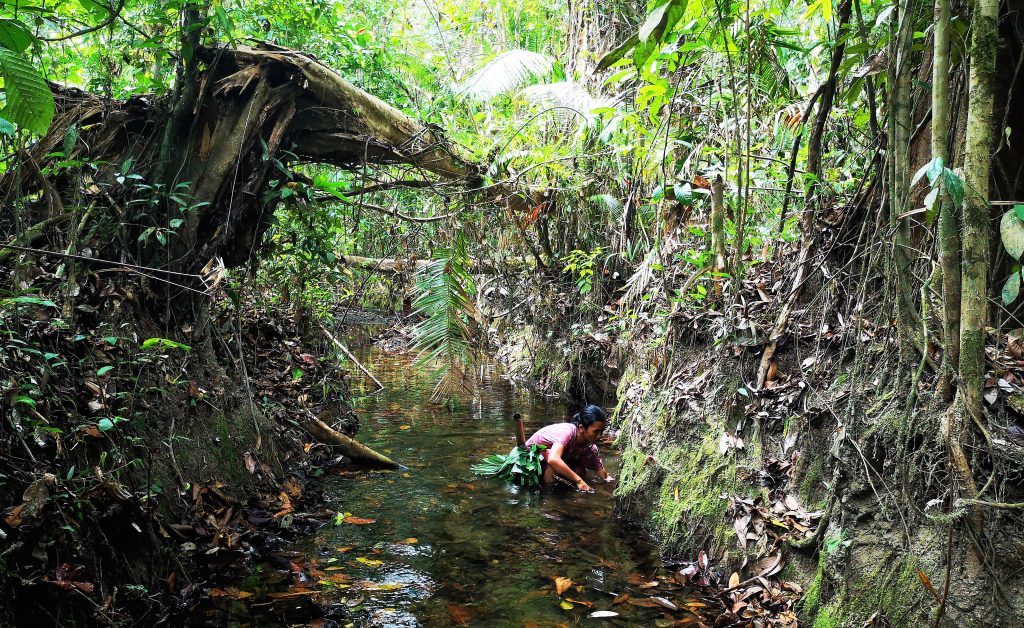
[209,329,702,627]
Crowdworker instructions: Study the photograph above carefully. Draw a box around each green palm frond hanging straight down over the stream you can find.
[413,234,480,402]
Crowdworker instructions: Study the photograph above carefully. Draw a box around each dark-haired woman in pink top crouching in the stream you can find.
[526,405,615,492]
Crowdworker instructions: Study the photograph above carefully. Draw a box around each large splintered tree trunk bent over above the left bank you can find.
[0,41,478,273]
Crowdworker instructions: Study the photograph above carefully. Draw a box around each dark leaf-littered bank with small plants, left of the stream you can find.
[0,249,376,622]
